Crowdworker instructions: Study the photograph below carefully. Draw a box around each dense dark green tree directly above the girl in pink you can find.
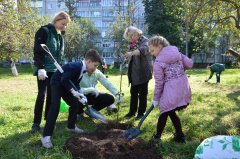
[143,0,183,47]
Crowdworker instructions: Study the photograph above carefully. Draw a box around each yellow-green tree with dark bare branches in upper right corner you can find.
[176,0,240,56]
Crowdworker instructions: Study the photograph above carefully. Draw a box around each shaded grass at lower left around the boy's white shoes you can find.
[0,118,97,159]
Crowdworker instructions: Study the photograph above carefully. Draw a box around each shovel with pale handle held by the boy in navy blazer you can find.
[40,44,107,123]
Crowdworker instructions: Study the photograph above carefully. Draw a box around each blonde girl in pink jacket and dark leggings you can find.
[148,36,193,142]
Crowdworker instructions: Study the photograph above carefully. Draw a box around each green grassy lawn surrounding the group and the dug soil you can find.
[0,65,240,159]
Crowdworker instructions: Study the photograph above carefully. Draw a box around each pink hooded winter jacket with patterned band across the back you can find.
[153,46,193,114]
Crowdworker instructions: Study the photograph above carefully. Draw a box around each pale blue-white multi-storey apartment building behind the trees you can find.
[30,0,146,64]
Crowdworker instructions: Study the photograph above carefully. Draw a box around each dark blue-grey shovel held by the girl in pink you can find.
[119,105,154,142]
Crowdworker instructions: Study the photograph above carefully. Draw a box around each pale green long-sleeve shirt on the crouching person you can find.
[80,69,118,96]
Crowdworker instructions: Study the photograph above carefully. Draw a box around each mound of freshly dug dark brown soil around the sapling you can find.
[64,123,161,159]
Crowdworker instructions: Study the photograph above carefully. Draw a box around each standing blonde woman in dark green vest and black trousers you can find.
[30,11,70,133]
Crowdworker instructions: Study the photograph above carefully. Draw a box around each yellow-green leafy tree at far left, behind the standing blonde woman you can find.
[0,0,47,62]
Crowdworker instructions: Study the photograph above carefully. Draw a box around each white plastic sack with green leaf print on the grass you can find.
[194,135,240,159]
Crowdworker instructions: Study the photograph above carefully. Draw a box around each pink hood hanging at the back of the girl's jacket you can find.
[156,46,180,64]
